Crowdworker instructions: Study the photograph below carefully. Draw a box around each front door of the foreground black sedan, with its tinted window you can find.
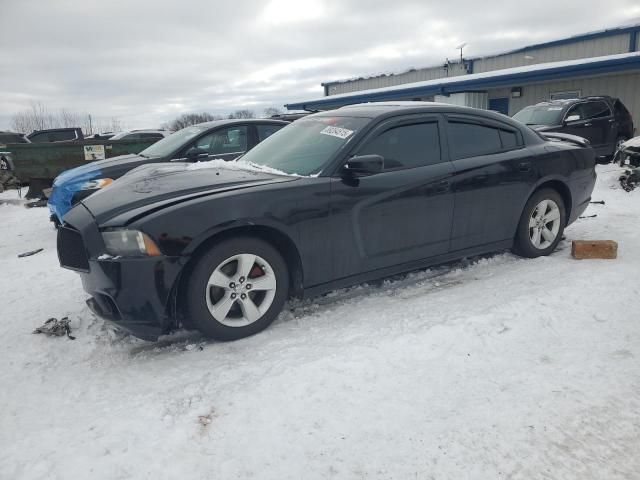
[331,115,453,278]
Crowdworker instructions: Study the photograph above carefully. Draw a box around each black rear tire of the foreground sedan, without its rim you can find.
[513,188,567,258]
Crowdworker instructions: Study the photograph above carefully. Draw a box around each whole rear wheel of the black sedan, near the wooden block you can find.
[514,188,567,258]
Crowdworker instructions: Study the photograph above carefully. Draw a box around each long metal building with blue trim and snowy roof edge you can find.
[286,23,640,126]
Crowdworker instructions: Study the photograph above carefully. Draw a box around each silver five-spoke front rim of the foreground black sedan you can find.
[205,253,277,327]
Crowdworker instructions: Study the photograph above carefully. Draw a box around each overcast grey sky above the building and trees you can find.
[0,0,640,128]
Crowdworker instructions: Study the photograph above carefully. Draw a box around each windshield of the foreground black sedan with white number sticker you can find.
[238,116,370,175]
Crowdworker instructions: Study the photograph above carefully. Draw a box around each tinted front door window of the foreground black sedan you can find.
[358,122,440,170]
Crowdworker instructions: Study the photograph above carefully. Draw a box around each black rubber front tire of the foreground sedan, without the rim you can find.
[184,237,289,341]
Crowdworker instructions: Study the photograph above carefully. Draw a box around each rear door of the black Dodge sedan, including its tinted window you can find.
[447,115,534,251]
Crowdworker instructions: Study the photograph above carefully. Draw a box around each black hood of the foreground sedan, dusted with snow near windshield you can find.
[82,160,296,226]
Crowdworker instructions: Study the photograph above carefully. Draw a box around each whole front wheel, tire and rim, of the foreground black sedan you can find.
[186,237,289,340]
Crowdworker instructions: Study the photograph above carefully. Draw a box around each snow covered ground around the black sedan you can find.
[0,165,640,480]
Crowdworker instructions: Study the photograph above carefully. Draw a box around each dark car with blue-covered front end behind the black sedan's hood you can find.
[48,119,289,226]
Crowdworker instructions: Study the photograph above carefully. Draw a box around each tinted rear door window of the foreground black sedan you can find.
[449,121,502,160]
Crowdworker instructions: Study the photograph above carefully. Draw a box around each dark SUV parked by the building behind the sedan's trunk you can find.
[513,96,634,158]
